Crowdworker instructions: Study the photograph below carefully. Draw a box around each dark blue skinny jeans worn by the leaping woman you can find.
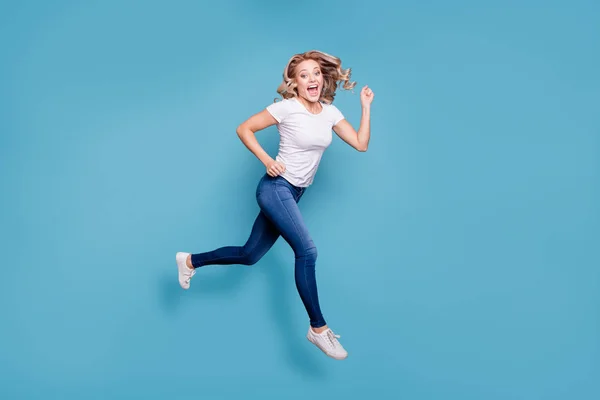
[191,174,326,328]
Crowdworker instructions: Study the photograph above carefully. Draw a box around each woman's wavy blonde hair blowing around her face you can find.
[277,50,356,104]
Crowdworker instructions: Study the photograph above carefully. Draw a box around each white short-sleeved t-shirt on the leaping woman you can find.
[267,98,344,187]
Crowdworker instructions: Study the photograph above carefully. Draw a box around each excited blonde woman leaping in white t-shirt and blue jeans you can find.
[175,51,374,360]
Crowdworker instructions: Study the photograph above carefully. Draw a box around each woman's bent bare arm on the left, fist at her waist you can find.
[236,109,285,176]
